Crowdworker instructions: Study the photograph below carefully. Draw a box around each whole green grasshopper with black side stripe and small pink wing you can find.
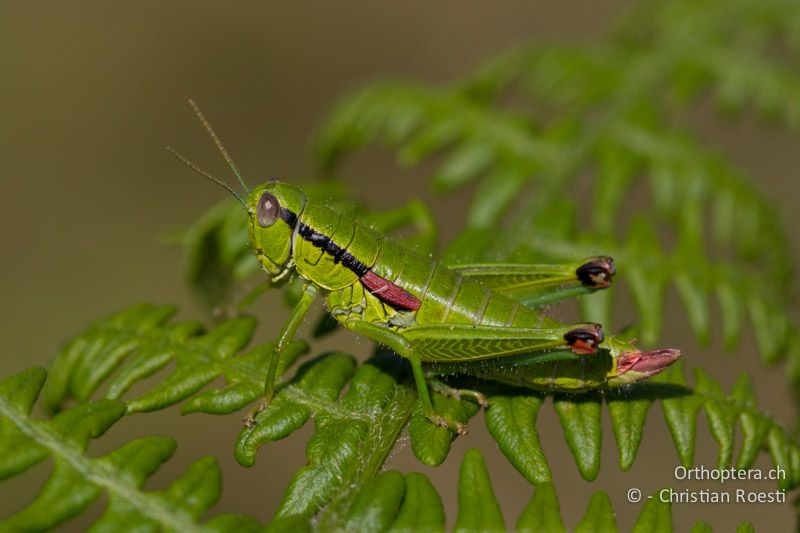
[175,101,680,433]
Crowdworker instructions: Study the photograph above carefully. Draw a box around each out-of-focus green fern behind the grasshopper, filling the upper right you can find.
[316,1,800,368]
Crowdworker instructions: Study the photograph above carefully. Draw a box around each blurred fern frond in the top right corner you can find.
[619,0,800,123]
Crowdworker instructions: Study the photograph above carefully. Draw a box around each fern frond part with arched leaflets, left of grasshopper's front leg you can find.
[44,304,307,414]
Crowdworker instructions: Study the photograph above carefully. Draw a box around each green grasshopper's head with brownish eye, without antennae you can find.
[247,181,306,278]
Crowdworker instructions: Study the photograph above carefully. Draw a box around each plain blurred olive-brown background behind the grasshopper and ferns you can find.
[0,0,800,531]
